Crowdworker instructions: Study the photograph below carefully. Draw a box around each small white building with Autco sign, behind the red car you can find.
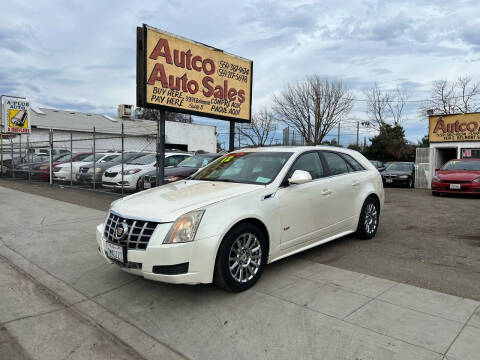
[427,113,480,187]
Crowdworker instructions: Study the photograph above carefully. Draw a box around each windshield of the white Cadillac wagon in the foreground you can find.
[192,151,292,185]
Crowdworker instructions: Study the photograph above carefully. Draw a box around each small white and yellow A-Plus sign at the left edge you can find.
[2,99,30,134]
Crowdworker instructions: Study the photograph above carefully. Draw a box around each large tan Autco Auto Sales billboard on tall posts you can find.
[137,25,253,122]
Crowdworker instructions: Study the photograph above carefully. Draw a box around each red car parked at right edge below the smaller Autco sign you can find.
[432,159,480,196]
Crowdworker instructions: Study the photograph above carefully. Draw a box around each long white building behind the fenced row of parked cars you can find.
[3,102,217,155]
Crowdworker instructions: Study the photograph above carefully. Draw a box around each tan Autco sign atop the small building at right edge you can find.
[428,113,480,142]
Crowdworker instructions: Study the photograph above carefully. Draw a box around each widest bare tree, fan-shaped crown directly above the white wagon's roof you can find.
[273,75,354,145]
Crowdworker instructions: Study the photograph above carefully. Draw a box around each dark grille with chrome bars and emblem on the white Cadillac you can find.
[103,213,158,250]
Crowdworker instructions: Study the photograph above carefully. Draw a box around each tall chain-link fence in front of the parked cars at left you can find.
[0,123,186,194]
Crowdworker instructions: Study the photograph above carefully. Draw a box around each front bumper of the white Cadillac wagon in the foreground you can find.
[96,223,218,284]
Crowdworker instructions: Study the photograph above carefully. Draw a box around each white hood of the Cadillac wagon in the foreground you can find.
[112,180,265,222]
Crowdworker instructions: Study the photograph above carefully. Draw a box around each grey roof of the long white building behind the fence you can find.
[30,108,214,135]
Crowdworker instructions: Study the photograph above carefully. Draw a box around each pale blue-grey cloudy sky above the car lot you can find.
[0,0,480,144]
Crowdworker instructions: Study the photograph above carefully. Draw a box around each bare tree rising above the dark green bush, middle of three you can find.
[365,83,408,130]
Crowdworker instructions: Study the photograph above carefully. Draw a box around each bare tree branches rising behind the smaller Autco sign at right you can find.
[420,76,480,116]
